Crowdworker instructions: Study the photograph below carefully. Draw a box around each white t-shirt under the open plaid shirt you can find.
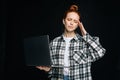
[64,36,73,75]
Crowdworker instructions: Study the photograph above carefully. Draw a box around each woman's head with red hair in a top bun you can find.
[63,5,80,32]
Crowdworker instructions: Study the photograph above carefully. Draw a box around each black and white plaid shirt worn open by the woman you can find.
[50,33,106,80]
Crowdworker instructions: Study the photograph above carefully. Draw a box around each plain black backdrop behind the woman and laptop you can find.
[0,0,120,80]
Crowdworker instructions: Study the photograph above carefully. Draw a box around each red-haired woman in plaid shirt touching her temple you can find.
[36,5,106,80]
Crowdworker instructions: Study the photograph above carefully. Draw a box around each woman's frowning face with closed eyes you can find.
[63,12,80,32]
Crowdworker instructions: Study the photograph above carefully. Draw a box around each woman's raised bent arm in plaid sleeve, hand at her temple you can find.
[79,22,106,61]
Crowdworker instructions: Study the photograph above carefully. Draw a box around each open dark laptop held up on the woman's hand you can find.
[24,35,51,66]
